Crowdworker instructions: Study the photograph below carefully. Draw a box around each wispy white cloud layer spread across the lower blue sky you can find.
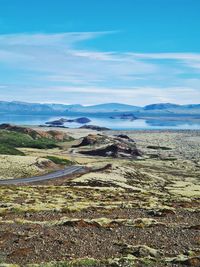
[0,32,200,105]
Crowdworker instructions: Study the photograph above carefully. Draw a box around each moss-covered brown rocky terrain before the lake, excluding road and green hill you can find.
[0,127,200,267]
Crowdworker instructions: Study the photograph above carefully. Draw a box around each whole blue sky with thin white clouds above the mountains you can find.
[0,0,200,106]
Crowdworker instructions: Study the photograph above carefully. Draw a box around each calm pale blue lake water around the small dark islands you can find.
[0,114,200,130]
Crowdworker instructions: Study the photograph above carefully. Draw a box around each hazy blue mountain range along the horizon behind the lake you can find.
[0,101,200,117]
